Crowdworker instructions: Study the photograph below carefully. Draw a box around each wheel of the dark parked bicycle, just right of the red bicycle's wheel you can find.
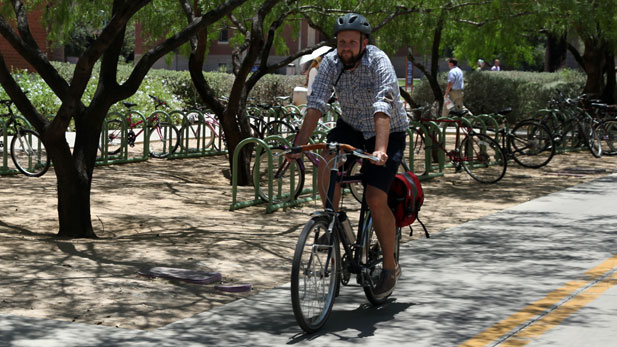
[508,120,555,169]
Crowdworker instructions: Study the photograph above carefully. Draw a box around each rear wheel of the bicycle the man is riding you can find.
[361,213,401,306]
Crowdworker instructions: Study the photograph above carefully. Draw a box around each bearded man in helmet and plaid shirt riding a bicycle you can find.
[287,13,409,299]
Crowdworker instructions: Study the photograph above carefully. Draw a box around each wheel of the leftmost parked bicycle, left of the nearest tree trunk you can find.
[11,129,51,177]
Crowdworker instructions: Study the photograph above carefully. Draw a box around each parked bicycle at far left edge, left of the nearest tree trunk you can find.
[0,99,51,177]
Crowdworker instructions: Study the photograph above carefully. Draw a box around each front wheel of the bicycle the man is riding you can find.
[291,216,340,333]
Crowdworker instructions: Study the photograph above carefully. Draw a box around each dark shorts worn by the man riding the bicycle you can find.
[326,119,406,193]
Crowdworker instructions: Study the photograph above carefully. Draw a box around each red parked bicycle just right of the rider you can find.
[410,110,507,183]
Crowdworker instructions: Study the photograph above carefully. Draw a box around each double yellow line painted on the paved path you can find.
[460,254,617,347]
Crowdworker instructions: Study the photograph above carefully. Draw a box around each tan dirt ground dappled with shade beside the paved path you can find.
[0,152,617,329]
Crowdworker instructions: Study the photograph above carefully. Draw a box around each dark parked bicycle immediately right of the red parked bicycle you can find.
[489,108,555,169]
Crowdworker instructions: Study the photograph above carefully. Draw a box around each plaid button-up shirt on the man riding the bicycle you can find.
[307,45,409,139]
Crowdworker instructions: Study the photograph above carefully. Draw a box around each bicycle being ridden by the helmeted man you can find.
[284,143,401,333]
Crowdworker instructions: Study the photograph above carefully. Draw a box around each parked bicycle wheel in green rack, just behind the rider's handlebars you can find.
[253,147,304,202]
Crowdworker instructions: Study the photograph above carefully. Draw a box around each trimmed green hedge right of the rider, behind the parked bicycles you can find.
[413,70,585,122]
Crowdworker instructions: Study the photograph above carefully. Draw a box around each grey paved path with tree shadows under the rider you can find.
[0,174,617,347]
